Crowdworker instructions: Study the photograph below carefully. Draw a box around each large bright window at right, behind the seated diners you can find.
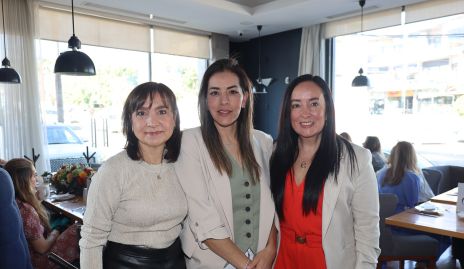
[333,14,464,166]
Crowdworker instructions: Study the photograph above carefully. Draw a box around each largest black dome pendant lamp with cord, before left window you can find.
[55,0,95,76]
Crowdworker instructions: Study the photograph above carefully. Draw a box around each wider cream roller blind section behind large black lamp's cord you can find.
[39,7,150,52]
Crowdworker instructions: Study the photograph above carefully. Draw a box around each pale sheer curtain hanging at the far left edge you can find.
[0,0,50,173]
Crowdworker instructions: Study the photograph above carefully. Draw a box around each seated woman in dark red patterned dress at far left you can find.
[5,159,79,269]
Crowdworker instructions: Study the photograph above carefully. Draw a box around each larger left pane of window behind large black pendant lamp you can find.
[37,40,149,161]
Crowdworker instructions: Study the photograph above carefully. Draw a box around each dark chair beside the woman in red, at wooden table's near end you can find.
[377,193,439,269]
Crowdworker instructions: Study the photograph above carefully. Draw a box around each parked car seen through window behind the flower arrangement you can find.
[47,124,98,171]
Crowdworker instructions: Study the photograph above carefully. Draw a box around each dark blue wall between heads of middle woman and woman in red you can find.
[230,29,301,138]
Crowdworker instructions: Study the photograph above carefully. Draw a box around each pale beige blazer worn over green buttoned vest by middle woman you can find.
[175,128,275,269]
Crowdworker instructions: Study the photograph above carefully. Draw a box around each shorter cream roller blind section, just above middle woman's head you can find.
[153,27,210,59]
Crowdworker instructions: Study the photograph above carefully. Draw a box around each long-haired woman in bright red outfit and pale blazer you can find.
[270,75,380,269]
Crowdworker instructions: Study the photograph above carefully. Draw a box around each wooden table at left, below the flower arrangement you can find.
[42,196,85,224]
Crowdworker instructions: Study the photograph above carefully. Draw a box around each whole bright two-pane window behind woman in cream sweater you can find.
[37,37,207,162]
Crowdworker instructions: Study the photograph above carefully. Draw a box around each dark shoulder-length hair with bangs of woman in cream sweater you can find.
[122,82,182,162]
